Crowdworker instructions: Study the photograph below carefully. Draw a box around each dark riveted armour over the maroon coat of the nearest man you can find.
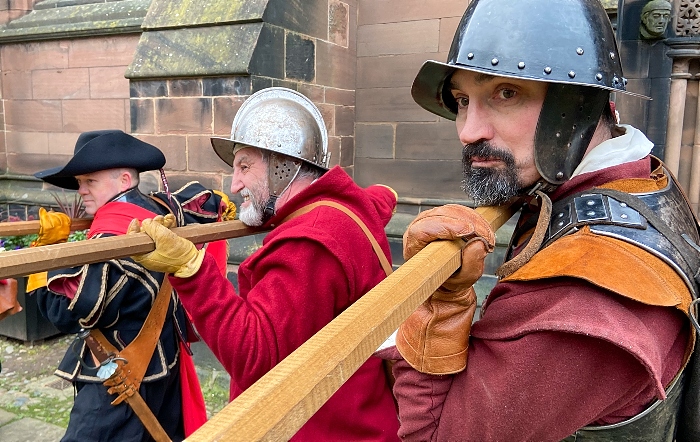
[514,171,700,442]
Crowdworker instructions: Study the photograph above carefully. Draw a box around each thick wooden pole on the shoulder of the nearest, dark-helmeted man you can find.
[187,205,518,442]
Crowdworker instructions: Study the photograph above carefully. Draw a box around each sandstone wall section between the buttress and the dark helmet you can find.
[355,0,469,199]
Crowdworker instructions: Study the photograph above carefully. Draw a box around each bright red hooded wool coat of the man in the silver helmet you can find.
[170,167,398,441]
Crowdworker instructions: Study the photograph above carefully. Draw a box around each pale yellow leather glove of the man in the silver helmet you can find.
[126,214,205,278]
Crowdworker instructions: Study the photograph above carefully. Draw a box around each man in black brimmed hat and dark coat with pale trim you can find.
[29,130,231,442]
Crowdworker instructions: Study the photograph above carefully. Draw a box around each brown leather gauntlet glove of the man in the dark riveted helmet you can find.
[396,204,496,374]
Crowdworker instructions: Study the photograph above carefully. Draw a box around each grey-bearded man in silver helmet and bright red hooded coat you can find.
[126,88,398,441]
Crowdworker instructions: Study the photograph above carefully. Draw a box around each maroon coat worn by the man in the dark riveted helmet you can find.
[393,157,690,442]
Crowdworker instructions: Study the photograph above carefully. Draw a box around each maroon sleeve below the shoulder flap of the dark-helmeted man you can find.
[394,332,655,441]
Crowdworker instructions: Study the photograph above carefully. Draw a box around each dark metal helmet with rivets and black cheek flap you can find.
[411,0,644,185]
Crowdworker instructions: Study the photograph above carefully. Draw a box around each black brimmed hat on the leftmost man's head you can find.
[34,130,165,190]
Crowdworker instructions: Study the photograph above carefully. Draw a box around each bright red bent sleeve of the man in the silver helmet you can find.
[170,239,349,389]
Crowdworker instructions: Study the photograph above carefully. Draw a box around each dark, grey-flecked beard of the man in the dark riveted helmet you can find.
[462,141,522,206]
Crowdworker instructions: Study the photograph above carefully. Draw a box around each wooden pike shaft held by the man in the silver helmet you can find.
[0,221,263,279]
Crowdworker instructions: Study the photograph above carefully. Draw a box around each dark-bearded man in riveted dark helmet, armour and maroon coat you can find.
[384,0,698,442]
